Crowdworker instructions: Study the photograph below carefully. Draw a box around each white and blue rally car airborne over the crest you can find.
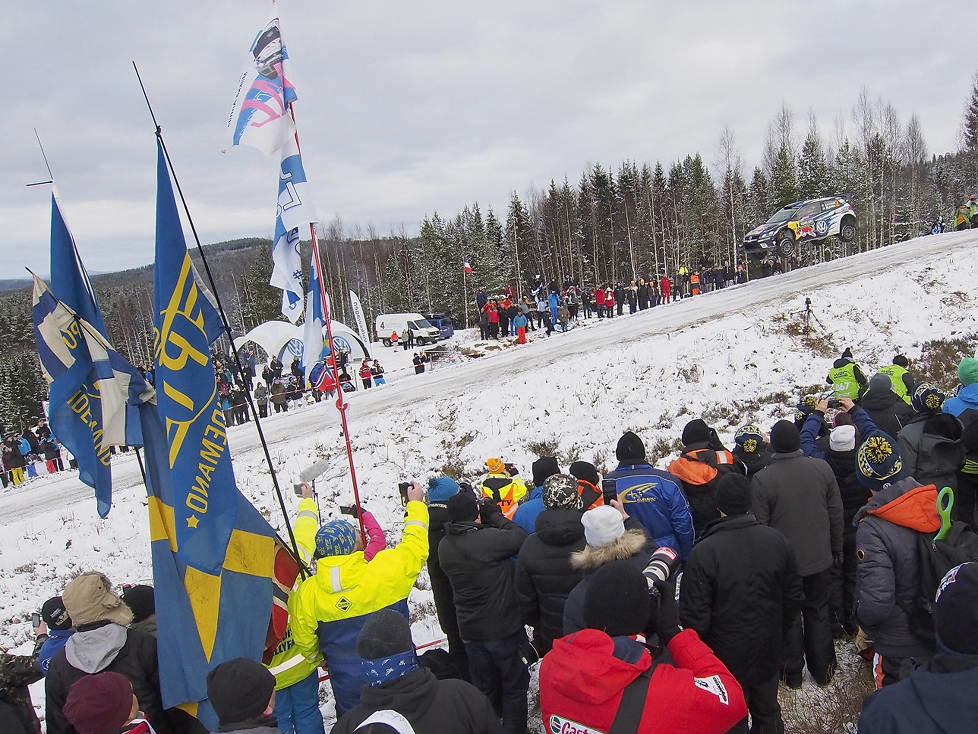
[743,196,856,260]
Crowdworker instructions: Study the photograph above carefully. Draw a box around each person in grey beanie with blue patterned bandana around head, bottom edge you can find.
[330,609,501,734]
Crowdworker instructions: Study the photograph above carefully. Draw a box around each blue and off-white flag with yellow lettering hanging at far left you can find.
[32,276,154,517]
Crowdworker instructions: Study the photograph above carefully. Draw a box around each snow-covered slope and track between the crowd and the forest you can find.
[0,232,978,732]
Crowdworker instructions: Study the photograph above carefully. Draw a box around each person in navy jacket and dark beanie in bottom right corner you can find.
[859,563,978,734]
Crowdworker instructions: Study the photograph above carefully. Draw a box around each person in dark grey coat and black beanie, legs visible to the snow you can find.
[752,420,842,688]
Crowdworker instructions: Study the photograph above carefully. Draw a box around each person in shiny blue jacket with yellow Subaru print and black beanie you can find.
[606,431,693,560]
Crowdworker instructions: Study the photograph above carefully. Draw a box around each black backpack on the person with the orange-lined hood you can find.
[907,521,978,645]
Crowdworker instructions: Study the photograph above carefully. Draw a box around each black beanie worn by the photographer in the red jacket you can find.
[581,564,649,637]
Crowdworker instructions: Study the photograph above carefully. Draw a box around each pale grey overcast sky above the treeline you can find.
[0,0,978,278]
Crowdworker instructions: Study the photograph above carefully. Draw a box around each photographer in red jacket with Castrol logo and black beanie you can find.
[540,561,747,734]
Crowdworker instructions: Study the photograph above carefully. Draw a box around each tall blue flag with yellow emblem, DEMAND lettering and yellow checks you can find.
[149,143,275,728]
